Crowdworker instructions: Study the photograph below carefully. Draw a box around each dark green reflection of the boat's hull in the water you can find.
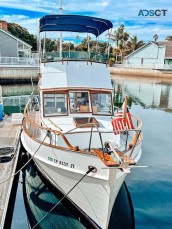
[23,164,134,229]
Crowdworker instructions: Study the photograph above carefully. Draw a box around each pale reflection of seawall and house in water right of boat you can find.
[112,75,172,112]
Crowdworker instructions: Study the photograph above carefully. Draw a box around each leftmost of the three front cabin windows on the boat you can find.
[44,93,67,116]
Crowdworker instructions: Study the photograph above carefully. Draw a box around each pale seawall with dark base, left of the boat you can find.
[0,66,38,84]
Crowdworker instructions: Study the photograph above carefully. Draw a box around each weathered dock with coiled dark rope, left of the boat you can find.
[0,116,21,229]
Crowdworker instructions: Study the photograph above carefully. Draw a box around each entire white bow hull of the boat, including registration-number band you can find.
[21,132,138,229]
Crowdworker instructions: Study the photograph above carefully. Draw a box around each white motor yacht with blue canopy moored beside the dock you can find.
[21,15,143,229]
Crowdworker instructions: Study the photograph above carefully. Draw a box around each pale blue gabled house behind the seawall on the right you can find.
[124,41,172,65]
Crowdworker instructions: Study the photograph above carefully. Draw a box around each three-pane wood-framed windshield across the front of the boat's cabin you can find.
[43,91,113,117]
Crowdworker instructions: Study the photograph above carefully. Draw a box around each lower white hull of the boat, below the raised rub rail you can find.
[35,160,125,228]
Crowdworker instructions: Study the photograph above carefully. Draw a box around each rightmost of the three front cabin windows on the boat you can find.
[91,92,112,115]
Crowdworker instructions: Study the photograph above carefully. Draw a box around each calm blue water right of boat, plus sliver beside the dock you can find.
[2,76,172,229]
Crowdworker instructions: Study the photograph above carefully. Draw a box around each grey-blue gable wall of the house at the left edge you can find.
[0,30,18,57]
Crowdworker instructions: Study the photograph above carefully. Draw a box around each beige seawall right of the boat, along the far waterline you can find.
[109,67,172,79]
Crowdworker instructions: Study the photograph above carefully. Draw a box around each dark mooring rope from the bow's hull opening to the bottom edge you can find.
[31,167,94,229]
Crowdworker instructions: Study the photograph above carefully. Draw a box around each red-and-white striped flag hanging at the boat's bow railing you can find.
[112,107,134,134]
